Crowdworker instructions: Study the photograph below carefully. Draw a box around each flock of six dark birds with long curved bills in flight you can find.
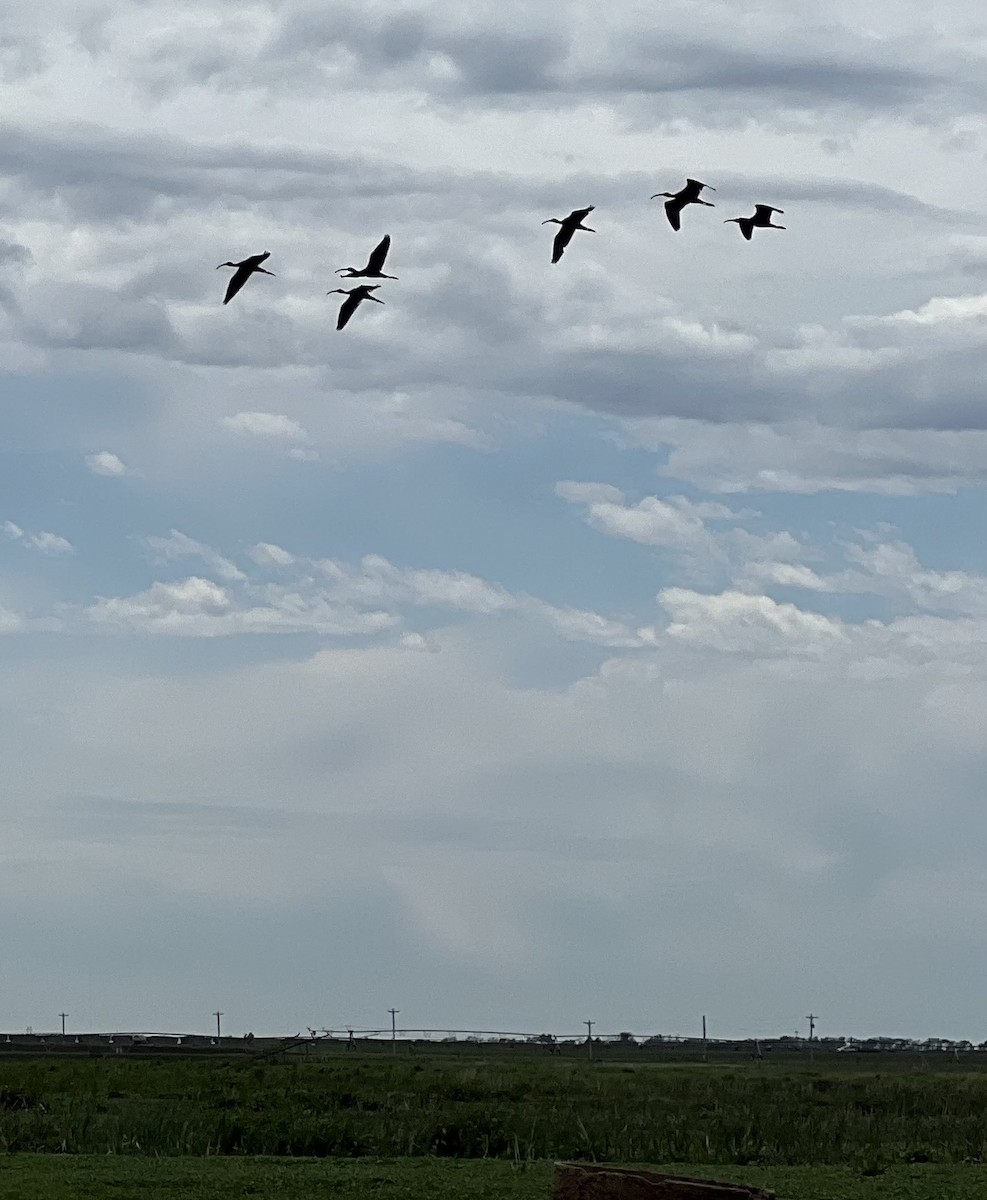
[216,179,785,329]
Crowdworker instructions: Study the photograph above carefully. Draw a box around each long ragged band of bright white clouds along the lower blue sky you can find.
[21,520,987,678]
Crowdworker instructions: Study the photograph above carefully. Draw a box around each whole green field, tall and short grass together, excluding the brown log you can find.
[0,1055,987,1200]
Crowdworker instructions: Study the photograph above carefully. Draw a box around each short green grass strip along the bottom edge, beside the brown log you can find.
[0,1154,987,1200]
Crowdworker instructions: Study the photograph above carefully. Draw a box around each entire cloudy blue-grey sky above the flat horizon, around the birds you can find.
[0,0,987,1039]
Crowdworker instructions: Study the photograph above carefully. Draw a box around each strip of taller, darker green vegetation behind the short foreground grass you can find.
[0,1057,987,1171]
